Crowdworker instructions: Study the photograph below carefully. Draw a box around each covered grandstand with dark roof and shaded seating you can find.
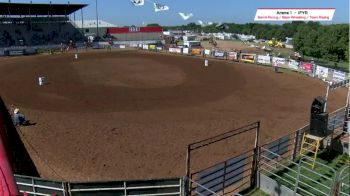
[0,3,87,47]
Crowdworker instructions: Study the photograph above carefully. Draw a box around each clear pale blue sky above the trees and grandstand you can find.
[0,0,349,26]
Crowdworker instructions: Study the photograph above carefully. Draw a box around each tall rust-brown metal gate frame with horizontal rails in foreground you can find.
[187,122,260,195]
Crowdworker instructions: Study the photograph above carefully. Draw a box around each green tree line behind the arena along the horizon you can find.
[160,21,349,62]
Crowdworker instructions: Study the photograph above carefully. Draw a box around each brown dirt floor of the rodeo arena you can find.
[0,51,346,181]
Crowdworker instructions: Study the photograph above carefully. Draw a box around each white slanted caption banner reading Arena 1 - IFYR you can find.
[254,8,335,21]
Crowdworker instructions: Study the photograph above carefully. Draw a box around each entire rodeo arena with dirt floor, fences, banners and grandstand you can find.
[0,2,350,196]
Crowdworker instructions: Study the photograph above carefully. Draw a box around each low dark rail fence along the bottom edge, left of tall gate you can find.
[15,175,184,196]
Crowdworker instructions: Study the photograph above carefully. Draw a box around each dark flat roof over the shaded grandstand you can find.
[0,2,87,16]
